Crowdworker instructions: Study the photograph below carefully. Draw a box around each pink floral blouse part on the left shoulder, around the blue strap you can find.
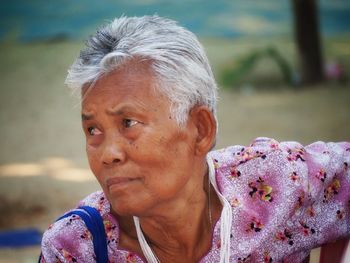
[42,191,119,262]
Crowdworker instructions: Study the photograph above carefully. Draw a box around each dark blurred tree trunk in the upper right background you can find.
[292,0,324,84]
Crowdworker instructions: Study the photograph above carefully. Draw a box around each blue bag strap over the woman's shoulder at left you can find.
[39,206,108,263]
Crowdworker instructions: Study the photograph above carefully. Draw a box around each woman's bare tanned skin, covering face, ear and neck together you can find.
[82,62,221,262]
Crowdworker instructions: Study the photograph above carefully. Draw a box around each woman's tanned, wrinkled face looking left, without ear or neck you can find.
[82,65,196,216]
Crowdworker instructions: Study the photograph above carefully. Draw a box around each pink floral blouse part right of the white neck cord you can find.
[209,138,350,261]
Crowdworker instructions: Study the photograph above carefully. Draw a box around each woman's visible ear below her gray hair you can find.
[190,106,216,156]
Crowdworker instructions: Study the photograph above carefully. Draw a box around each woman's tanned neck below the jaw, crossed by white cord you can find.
[118,176,221,262]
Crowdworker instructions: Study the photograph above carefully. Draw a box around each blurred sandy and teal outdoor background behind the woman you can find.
[0,0,350,263]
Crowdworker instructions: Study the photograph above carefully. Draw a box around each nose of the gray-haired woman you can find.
[101,138,125,165]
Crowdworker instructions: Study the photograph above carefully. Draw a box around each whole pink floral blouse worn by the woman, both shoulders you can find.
[41,138,350,263]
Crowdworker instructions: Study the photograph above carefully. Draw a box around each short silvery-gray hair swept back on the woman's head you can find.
[66,16,217,125]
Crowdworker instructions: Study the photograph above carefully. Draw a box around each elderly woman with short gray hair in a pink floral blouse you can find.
[41,16,350,263]
